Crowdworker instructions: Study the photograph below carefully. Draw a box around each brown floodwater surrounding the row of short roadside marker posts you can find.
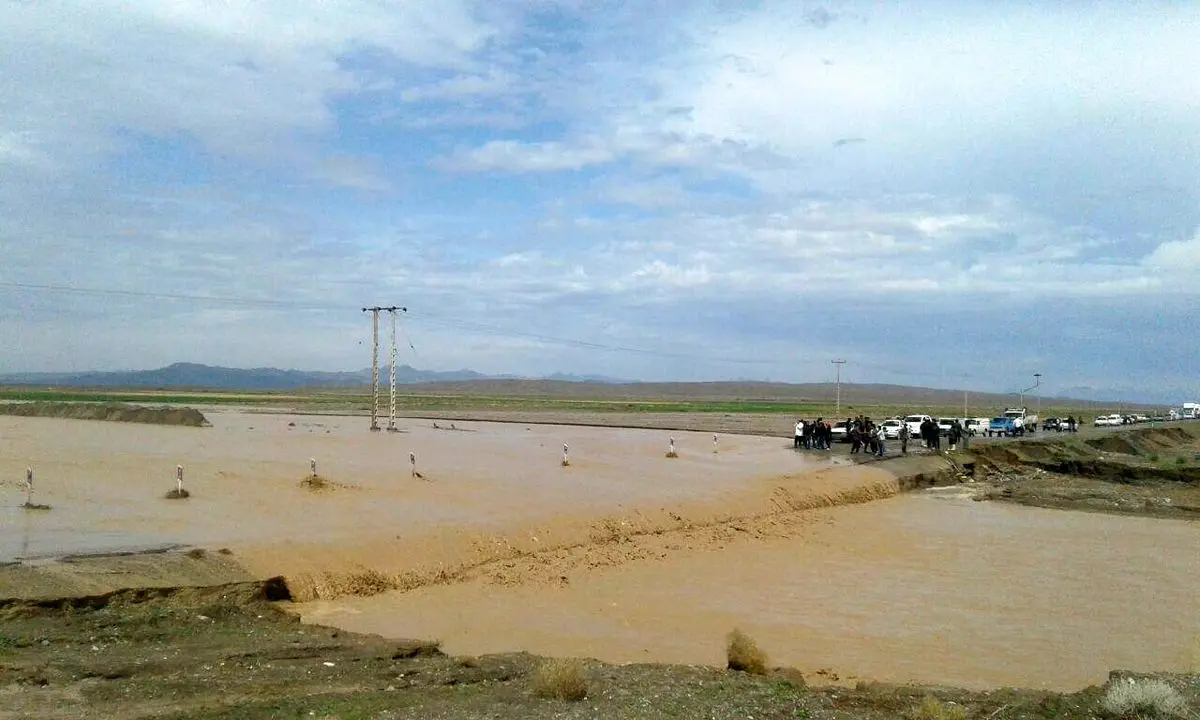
[0,412,830,559]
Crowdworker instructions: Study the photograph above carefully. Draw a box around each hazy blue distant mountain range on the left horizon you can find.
[0,362,620,390]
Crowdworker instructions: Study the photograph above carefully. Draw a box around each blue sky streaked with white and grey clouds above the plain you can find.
[0,0,1200,402]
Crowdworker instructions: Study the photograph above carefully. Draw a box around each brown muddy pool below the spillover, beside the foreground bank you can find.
[299,491,1200,690]
